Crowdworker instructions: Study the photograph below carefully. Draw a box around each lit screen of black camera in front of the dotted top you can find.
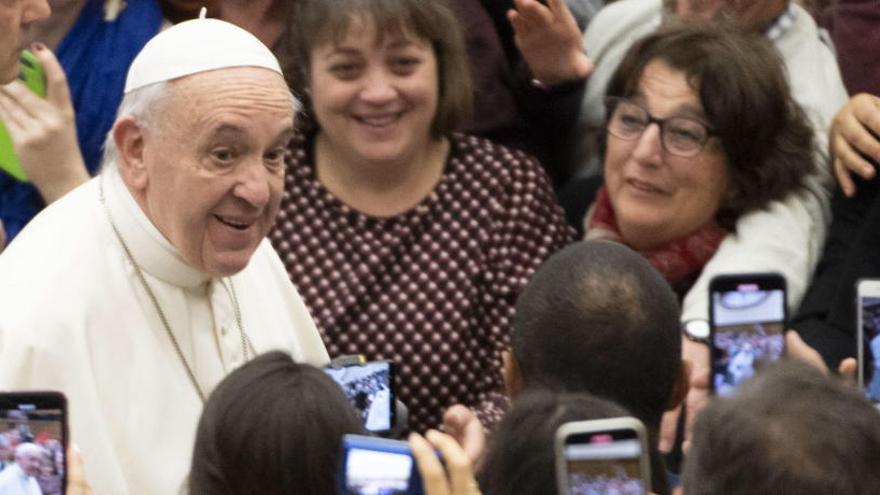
[324,356,396,433]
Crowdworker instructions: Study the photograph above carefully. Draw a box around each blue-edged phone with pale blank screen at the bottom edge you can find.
[338,435,423,495]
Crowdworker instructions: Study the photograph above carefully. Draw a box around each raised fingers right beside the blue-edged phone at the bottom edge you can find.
[409,430,480,495]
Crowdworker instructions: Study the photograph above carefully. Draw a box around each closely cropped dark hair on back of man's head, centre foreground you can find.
[511,241,681,429]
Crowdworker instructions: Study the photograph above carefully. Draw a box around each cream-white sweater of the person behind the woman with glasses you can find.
[581,0,847,321]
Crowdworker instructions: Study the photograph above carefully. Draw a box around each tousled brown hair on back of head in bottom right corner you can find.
[684,360,880,495]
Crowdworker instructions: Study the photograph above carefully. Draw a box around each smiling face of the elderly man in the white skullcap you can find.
[129,67,293,276]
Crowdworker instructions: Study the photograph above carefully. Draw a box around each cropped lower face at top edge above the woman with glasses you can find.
[666,0,789,30]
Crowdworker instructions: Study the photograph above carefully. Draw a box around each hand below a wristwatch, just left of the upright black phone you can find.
[659,338,710,458]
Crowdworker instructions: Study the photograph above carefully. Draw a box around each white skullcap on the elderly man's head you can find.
[125,12,281,94]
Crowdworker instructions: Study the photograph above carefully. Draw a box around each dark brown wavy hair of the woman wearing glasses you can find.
[607,23,816,230]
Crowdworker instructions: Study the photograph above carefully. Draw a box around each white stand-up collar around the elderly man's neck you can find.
[100,166,211,289]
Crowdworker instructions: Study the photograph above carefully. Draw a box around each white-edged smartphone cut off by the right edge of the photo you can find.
[856,279,880,403]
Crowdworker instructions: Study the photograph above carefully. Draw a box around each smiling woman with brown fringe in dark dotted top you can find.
[270,0,572,431]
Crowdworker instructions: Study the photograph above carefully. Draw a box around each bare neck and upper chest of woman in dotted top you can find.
[315,133,449,217]
